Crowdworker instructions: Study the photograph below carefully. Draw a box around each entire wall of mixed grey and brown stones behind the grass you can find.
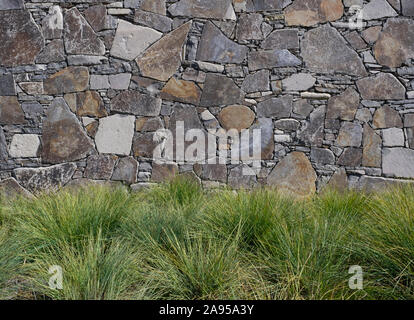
[0,0,414,195]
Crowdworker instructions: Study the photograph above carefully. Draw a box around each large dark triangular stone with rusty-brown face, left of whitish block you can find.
[42,98,94,164]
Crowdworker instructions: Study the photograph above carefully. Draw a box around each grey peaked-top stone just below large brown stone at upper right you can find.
[357,72,405,100]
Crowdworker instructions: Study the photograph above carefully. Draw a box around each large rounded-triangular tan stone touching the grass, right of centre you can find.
[267,151,317,197]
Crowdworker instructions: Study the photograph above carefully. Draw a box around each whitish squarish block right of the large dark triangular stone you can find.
[95,114,135,156]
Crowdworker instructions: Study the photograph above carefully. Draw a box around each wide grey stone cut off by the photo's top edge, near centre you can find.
[168,0,236,20]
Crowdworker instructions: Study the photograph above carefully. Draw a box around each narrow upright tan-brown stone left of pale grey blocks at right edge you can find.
[362,123,382,168]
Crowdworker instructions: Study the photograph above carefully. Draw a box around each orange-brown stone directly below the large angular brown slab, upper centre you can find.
[161,78,201,105]
